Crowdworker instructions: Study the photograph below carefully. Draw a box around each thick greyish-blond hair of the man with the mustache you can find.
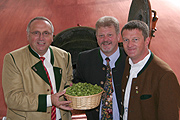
[96,16,120,34]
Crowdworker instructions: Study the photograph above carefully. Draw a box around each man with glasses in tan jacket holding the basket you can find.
[2,17,73,120]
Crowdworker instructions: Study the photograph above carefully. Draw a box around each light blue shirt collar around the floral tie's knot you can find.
[100,47,120,68]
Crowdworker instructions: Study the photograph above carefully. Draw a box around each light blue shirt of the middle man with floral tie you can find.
[99,48,120,120]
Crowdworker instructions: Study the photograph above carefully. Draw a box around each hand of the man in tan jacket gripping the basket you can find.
[51,90,73,110]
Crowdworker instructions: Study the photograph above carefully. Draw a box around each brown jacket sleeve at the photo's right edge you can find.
[158,71,180,120]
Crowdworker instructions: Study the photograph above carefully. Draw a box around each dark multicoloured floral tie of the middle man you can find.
[101,58,113,120]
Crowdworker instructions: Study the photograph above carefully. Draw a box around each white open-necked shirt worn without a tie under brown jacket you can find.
[123,50,151,120]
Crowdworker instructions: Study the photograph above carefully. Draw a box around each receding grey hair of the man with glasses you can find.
[26,16,54,33]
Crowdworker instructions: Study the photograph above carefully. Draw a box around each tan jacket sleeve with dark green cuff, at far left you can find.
[2,54,46,111]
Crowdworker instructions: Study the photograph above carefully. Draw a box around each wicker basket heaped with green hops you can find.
[64,82,104,110]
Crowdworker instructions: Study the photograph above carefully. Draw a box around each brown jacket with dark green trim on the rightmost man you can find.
[122,53,180,120]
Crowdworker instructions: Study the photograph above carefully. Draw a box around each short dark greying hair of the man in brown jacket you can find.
[121,20,149,40]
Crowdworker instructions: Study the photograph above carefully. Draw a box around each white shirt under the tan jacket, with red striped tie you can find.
[39,49,61,120]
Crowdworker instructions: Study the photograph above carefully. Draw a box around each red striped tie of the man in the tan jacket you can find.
[40,57,56,120]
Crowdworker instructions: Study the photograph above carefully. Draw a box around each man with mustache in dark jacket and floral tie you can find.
[74,16,126,120]
